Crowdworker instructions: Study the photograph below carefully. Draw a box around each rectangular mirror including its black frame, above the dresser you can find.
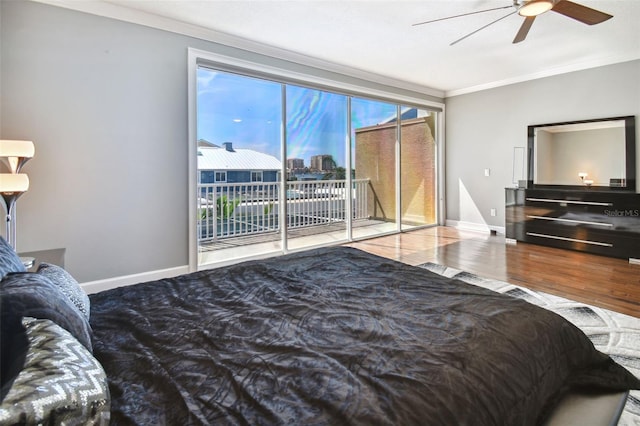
[528,116,636,191]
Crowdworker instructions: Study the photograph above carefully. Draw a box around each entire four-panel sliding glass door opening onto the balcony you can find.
[194,66,437,267]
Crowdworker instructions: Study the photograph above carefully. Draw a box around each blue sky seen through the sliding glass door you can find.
[198,68,396,166]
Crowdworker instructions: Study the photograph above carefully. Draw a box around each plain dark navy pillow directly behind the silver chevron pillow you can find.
[0,272,92,351]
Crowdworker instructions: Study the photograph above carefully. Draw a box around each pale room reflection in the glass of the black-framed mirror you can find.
[534,120,626,186]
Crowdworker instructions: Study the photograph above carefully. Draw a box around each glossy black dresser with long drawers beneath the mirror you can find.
[505,188,640,263]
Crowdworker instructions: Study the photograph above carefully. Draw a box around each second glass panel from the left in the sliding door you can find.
[285,85,347,250]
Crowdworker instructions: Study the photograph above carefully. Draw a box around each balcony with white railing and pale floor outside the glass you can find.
[198,179,424,268]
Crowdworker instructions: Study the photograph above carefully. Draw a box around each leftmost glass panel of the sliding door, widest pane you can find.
[197,67,283,265]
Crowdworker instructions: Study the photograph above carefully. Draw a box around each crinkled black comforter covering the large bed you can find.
[0,240,640,425]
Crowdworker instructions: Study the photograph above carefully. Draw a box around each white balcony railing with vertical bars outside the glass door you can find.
[198,179,369,242]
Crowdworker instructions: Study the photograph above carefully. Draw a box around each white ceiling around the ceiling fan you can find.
[45,0,640,96]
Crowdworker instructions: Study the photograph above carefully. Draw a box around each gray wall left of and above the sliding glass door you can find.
[0,1,442,282]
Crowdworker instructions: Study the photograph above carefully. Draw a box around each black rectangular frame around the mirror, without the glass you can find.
[527,115,636,192]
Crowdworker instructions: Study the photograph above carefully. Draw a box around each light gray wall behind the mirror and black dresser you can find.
[445,60,640,229]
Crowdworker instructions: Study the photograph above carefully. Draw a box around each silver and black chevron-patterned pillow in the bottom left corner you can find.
[0,318,111,425]
